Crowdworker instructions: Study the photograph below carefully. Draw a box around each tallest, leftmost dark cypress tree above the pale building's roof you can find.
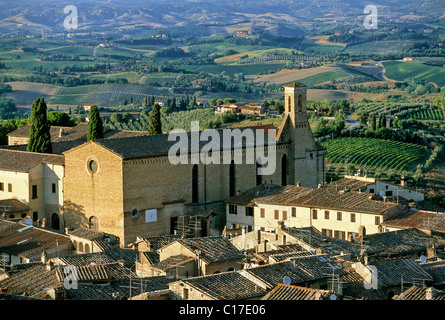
[27,98,53,153]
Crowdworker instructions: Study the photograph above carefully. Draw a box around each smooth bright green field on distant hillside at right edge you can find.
[383,61,445,87]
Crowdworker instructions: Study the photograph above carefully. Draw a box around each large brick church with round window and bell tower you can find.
[62,83,326,246]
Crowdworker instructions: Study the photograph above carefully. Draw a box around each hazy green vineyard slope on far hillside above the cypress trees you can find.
[48,83,171,107]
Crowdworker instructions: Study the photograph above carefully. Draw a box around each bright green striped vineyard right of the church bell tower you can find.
[321,137,426,171]
